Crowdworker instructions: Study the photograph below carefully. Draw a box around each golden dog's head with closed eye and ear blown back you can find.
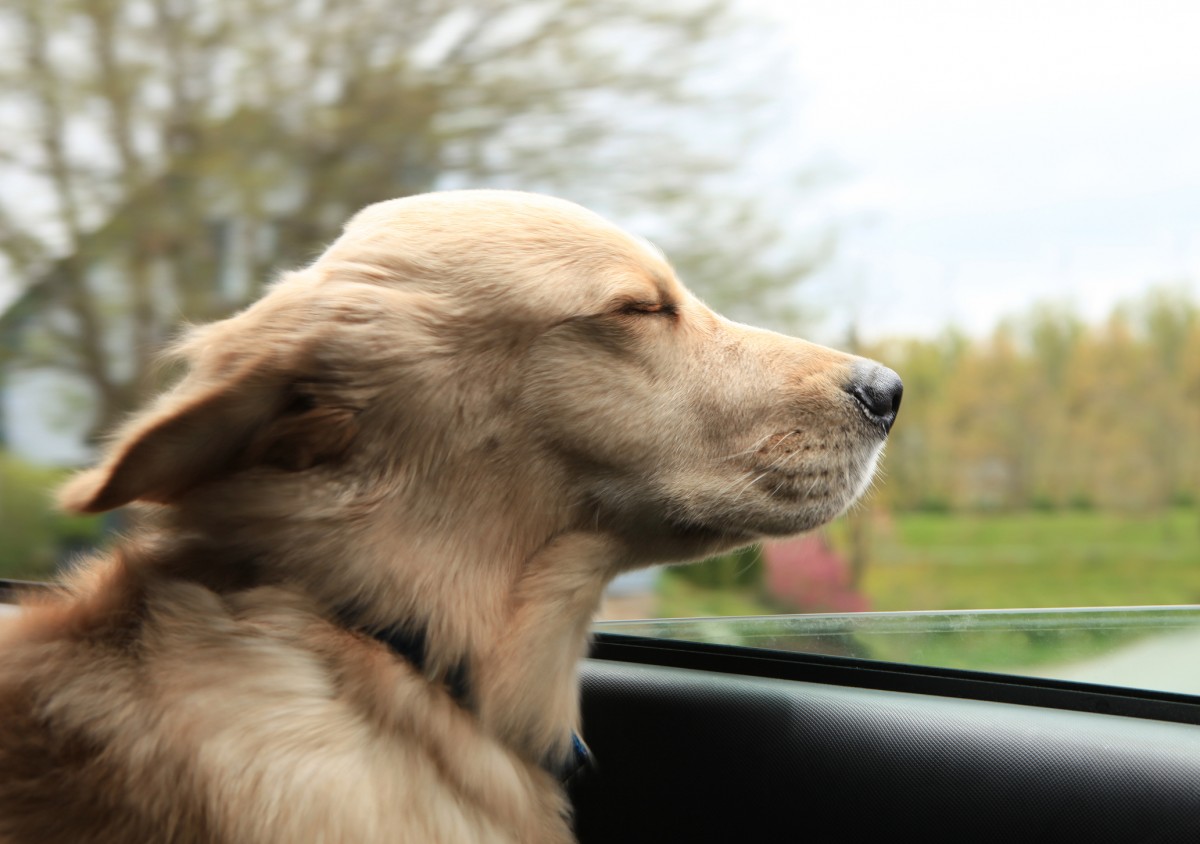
[61,191,901,571]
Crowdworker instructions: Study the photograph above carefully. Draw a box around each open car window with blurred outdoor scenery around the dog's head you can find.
[0,0,1200,688]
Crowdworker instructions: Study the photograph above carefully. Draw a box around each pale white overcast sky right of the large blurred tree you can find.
[748,0,1200,340]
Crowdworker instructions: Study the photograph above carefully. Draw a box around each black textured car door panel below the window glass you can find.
[572,659,1200,844]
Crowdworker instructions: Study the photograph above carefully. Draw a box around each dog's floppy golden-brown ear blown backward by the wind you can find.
[59,350,358,513]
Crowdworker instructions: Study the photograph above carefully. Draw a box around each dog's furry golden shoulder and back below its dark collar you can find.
[0,561,569,842]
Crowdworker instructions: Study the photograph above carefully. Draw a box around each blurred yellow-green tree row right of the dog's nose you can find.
[866,288,1200,513]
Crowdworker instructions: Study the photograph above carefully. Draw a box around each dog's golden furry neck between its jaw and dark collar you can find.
[158,485,623,767]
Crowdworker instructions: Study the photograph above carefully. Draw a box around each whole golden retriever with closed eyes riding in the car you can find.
[0,191,901,844]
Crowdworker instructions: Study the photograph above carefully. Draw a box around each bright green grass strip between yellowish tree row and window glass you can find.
[849,509,1200,610]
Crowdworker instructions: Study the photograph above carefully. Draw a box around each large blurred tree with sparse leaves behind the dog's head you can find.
[0,0,821,441]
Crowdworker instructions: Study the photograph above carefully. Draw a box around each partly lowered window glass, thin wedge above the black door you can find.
[595,606,1200,695]
